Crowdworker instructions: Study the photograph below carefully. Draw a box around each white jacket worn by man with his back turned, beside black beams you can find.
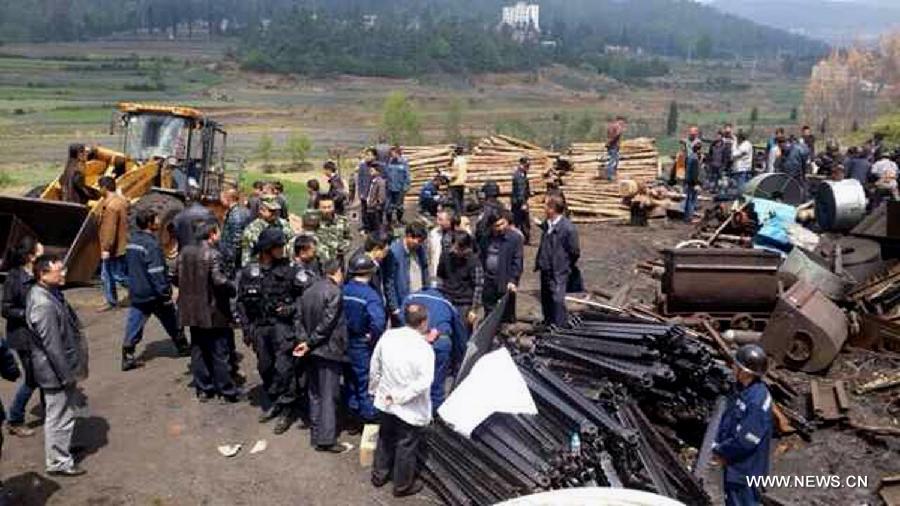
[369,327,434,427]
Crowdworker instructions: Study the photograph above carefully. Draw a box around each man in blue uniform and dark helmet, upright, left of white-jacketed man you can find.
[343,253,386,424]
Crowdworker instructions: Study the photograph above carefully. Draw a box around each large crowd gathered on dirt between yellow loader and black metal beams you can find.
[0,142,581,496]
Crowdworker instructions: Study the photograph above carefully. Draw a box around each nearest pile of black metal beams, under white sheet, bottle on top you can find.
[422,354,709,505]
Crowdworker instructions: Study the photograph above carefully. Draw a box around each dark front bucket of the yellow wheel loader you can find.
[0,197,100,285]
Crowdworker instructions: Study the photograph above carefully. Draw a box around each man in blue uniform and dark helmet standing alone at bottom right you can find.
[713,344,772,506]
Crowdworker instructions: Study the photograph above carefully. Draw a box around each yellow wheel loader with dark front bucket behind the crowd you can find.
[0,103,239,284]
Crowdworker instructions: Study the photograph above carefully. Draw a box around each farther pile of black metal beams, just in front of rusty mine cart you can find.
[536,312,732,434]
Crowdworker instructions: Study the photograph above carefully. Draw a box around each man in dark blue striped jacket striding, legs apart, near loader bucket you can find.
[122,209,191,371]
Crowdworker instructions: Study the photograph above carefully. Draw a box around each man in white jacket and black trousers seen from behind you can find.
[369,304,437,497]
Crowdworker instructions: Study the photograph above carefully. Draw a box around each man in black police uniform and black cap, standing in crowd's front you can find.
[237,227,308,434]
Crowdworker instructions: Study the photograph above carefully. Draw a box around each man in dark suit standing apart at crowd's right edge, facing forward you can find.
[534,194,580,326]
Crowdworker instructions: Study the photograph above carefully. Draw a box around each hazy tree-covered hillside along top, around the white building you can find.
[0,0,827,81]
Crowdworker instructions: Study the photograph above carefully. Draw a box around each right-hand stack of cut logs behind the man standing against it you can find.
[560,137,659,223]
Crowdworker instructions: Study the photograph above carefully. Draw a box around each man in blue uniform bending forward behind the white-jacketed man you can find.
[401,278,469,411]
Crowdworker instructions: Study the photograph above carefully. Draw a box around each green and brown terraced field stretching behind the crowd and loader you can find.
[0,41,804,193]
